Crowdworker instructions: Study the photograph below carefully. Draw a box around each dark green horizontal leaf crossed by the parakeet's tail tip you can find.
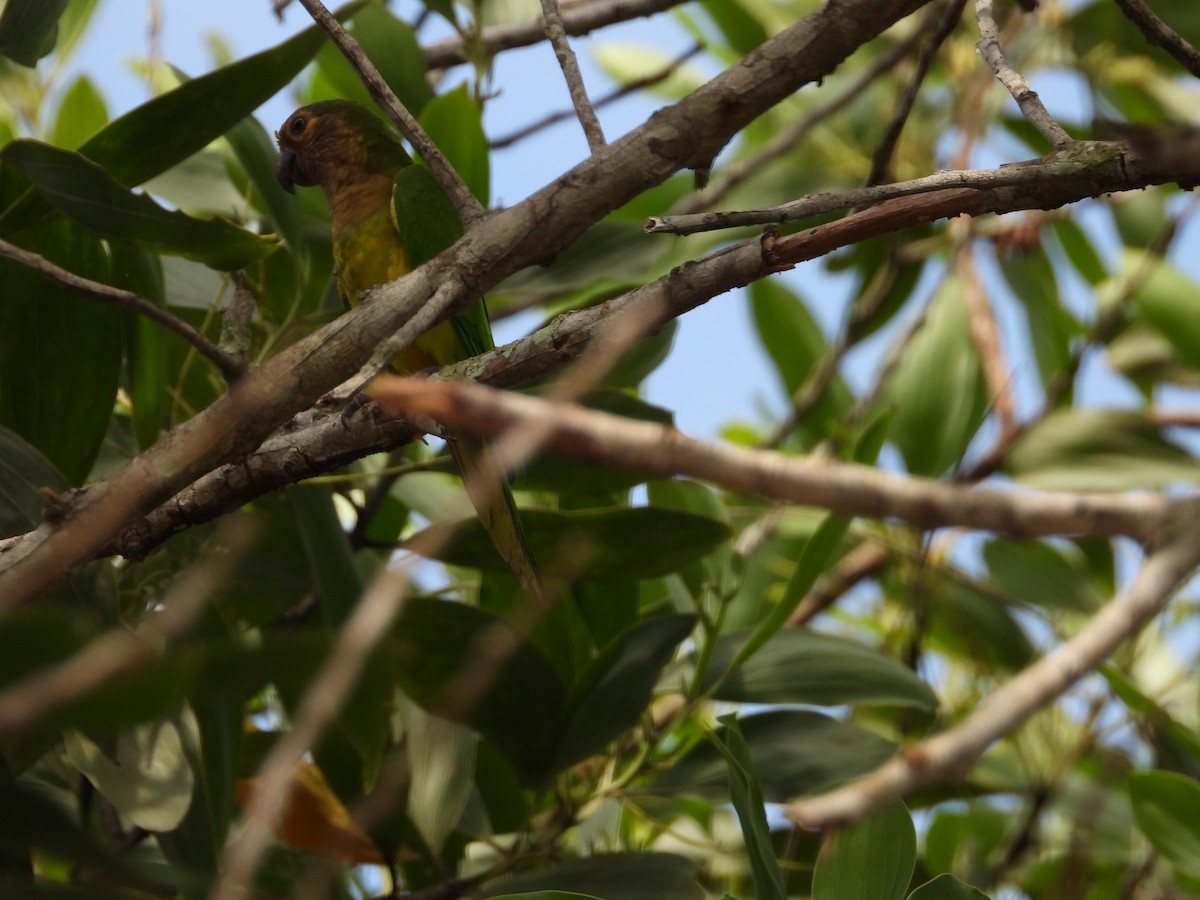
[404,506,730,581]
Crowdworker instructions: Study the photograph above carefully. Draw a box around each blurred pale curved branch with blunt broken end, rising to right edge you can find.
[787,520,1200,829]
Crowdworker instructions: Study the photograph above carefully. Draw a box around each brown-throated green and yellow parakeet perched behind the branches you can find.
[275,100,540,593]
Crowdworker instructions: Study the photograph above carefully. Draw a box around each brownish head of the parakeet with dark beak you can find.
[275,100,410,194]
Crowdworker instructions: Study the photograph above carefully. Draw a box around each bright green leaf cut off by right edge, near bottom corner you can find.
[1129,769,1200,878]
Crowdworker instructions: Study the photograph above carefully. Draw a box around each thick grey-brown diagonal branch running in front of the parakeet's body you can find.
[0,0,923,605]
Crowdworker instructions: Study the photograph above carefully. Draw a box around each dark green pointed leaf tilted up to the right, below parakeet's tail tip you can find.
[550,616,696,772]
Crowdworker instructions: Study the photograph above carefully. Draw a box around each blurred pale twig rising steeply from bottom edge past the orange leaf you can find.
[211,571,409,900]
